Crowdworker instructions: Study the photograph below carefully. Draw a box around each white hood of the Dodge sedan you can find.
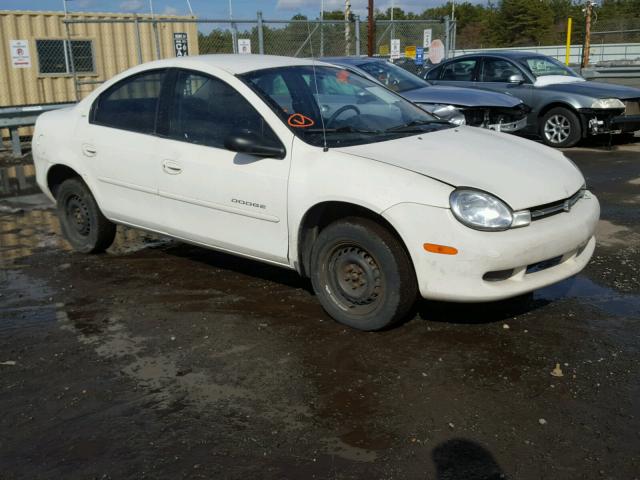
[337,127,584,210]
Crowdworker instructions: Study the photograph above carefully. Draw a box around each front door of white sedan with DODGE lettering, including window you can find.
[157,70,290,263]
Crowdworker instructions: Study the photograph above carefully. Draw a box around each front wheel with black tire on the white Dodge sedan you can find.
[311,217,418,331]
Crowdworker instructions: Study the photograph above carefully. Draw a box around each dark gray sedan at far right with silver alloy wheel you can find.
[425,51,640,147]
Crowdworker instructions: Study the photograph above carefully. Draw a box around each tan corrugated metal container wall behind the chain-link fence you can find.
[0,10,198,106]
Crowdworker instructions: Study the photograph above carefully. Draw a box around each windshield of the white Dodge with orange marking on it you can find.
[240,66,451,147]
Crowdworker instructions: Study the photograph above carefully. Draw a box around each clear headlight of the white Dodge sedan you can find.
[449,188,531,231]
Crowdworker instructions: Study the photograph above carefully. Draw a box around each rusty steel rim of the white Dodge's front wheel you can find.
[327,243,384,315]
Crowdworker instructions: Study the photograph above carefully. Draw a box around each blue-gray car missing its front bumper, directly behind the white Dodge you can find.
[321,57,530,132]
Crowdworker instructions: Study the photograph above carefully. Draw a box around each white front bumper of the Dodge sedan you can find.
[383,193,600,302]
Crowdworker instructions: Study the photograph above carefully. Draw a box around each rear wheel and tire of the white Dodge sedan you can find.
[56,178,116,253]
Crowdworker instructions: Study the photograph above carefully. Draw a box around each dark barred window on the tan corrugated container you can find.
[36,40,95,75]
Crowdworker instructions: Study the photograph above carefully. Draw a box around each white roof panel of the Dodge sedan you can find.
[146,54,330,75]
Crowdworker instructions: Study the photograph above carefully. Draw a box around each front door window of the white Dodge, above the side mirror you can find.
[169,71,278,148]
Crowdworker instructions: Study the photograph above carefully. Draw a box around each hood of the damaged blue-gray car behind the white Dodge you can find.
[400,85,522,108]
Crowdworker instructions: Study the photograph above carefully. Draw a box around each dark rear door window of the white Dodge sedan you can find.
[91,70,165,133]
